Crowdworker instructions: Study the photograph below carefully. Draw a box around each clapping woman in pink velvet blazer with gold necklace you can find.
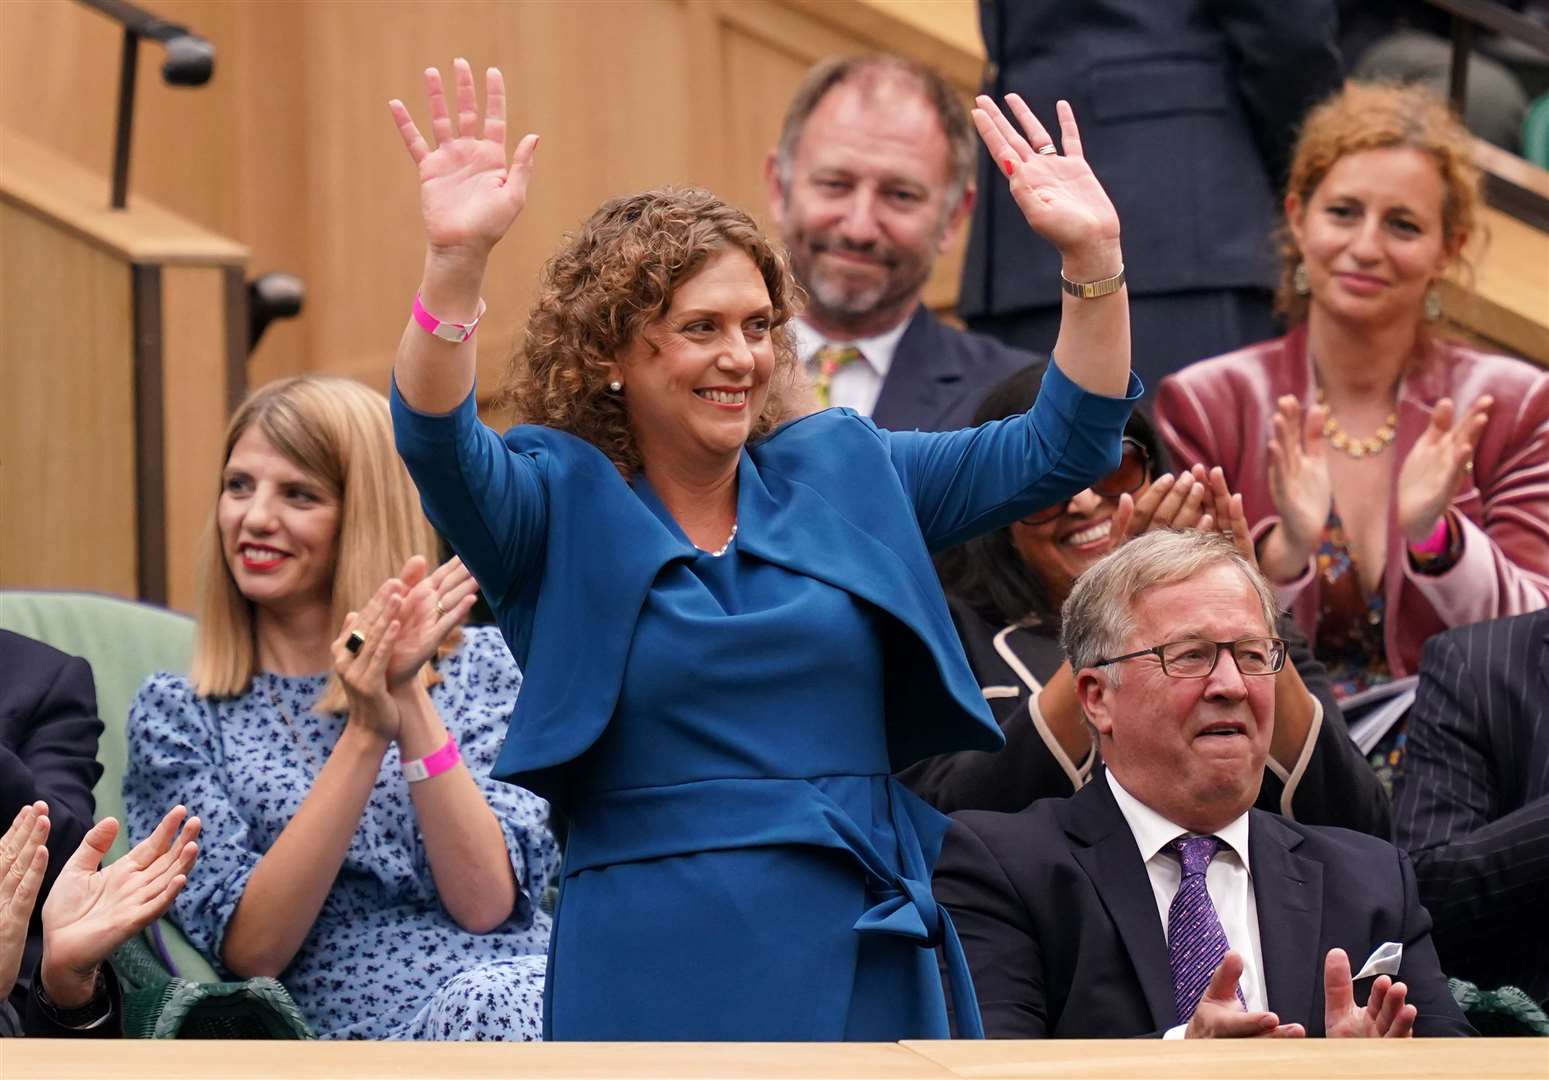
[1156,84,1549,693]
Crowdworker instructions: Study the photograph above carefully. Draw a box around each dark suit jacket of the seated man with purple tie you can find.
[934,778,1472,1038]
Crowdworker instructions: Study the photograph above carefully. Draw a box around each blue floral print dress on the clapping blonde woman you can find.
[124,628,559,1040]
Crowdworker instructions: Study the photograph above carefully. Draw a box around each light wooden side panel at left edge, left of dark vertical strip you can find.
[0,203,136,597]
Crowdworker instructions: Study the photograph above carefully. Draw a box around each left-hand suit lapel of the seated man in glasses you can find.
[1063,775,1177,1029]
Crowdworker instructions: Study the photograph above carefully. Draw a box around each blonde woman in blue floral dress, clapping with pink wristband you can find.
[124,377,558,1040]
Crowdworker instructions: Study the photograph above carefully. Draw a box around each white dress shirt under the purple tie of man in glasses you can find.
[1104,770,1269,1038]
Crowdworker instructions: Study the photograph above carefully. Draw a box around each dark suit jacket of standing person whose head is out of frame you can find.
[959,0,1340,319]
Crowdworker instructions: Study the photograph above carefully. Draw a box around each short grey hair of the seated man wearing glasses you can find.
[1060,528,1279,686]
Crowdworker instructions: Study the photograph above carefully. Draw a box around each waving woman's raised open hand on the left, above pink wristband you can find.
[387,57,538,259]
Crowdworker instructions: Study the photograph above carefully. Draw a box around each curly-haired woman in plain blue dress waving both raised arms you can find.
[392,60,1139,1040]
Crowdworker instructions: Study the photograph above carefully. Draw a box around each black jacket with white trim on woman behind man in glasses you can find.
[898,601,1393,840]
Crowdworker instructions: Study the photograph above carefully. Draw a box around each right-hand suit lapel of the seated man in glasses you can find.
[1248,810,1319,1035]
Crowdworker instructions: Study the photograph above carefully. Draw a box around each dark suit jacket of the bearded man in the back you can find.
[871,303,1039,431]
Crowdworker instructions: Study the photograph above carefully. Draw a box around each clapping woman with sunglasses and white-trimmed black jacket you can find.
[900,367,1389,837]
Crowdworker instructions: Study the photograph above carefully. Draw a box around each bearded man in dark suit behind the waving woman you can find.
[765,56,1036,431]
